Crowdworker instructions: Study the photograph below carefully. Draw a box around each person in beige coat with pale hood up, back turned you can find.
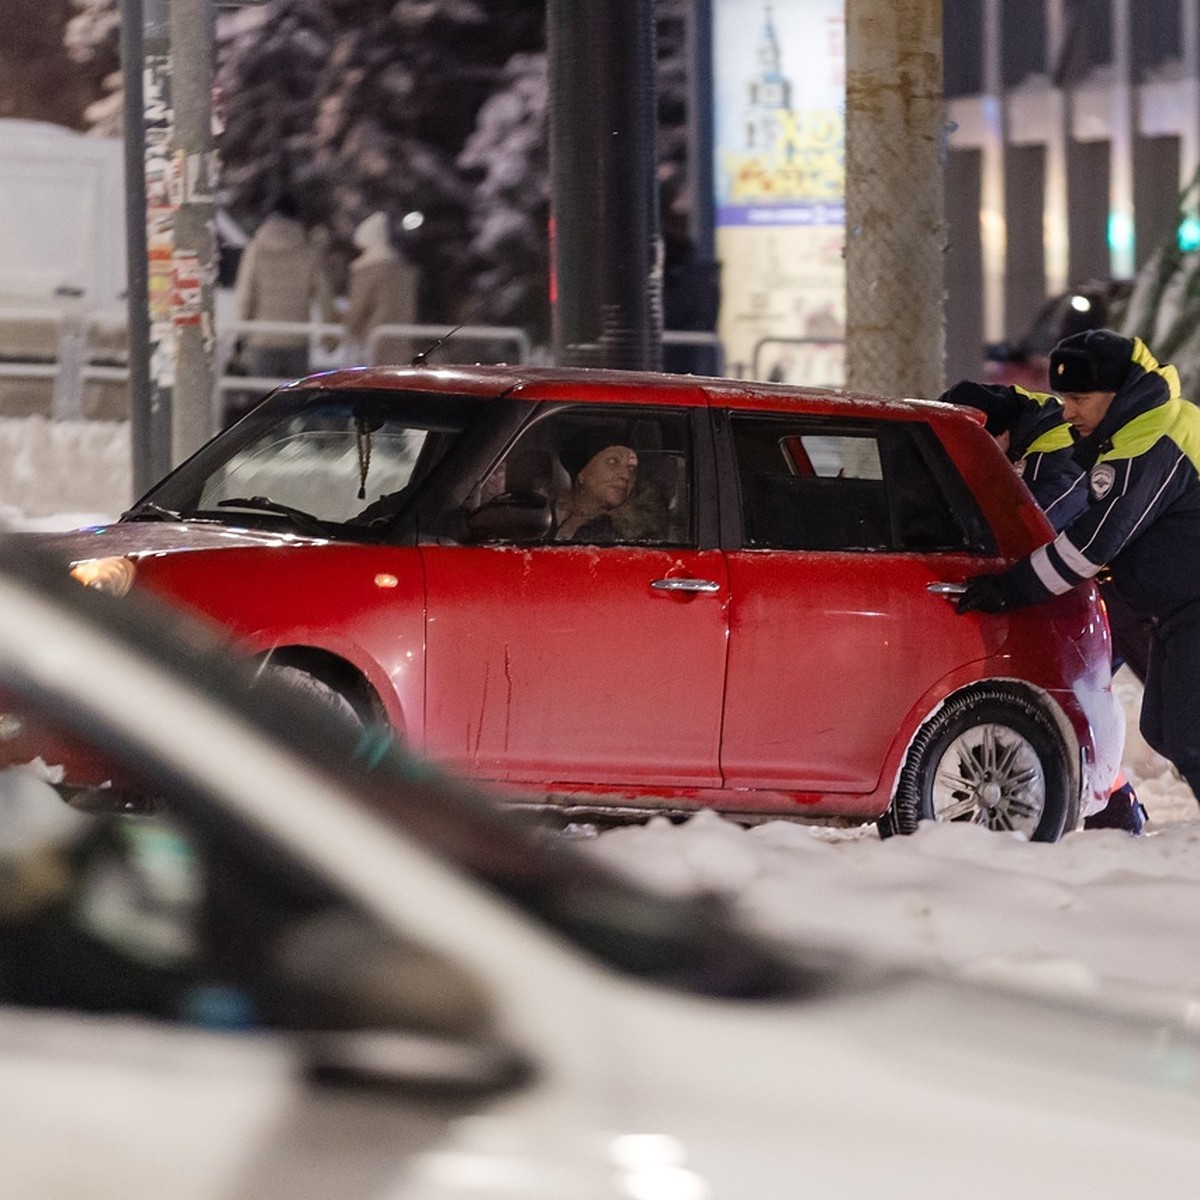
[344,212,419,364]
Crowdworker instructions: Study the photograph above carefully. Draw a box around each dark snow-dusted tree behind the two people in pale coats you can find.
[220,0,541,319]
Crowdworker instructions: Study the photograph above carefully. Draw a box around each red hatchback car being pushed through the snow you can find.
[21,367,1123,840]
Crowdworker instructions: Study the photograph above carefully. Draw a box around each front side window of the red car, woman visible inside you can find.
[469,406,695,546]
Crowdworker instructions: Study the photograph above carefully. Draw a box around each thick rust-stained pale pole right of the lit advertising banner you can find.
[846,0,946,396]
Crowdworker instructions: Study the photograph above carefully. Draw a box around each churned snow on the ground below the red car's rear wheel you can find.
[584,802,1200,1021]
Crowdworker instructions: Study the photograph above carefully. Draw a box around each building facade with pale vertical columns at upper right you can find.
[943,0,1200,379]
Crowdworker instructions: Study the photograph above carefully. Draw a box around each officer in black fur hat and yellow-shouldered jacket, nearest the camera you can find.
[958,329,1200,798]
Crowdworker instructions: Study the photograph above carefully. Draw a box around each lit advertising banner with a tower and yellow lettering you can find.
[713,0,846,385]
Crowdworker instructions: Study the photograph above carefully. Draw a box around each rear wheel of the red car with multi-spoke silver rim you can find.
[878,685,1079,841]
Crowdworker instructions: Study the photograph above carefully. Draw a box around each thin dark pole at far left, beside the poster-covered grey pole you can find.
[121,0,155,498]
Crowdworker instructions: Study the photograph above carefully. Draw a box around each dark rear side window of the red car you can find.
[731,414,978,551]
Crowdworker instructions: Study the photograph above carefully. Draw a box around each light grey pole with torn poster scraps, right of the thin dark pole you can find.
[170,0,217,464]
